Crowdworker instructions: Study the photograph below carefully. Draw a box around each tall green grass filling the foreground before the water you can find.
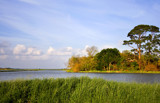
[0,77,160,103]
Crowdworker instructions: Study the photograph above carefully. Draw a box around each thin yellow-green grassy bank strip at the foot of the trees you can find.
[66,69,160,74]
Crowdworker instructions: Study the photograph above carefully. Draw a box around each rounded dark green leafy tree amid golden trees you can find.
[95,48,120,70]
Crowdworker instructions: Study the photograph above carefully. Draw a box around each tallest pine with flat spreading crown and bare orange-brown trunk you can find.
[123,25,159,68]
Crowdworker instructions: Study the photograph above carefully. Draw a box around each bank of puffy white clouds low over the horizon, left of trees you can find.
[0,44,99,68]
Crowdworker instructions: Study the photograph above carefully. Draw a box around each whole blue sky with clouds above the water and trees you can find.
[0,0,160,69]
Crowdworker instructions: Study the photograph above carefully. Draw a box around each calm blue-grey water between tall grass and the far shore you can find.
[0,70,160,83]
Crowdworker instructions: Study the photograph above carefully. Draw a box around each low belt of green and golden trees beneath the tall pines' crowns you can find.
[68,46,160,72]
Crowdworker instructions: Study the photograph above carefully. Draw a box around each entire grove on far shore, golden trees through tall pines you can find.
[68,25,160,72]
